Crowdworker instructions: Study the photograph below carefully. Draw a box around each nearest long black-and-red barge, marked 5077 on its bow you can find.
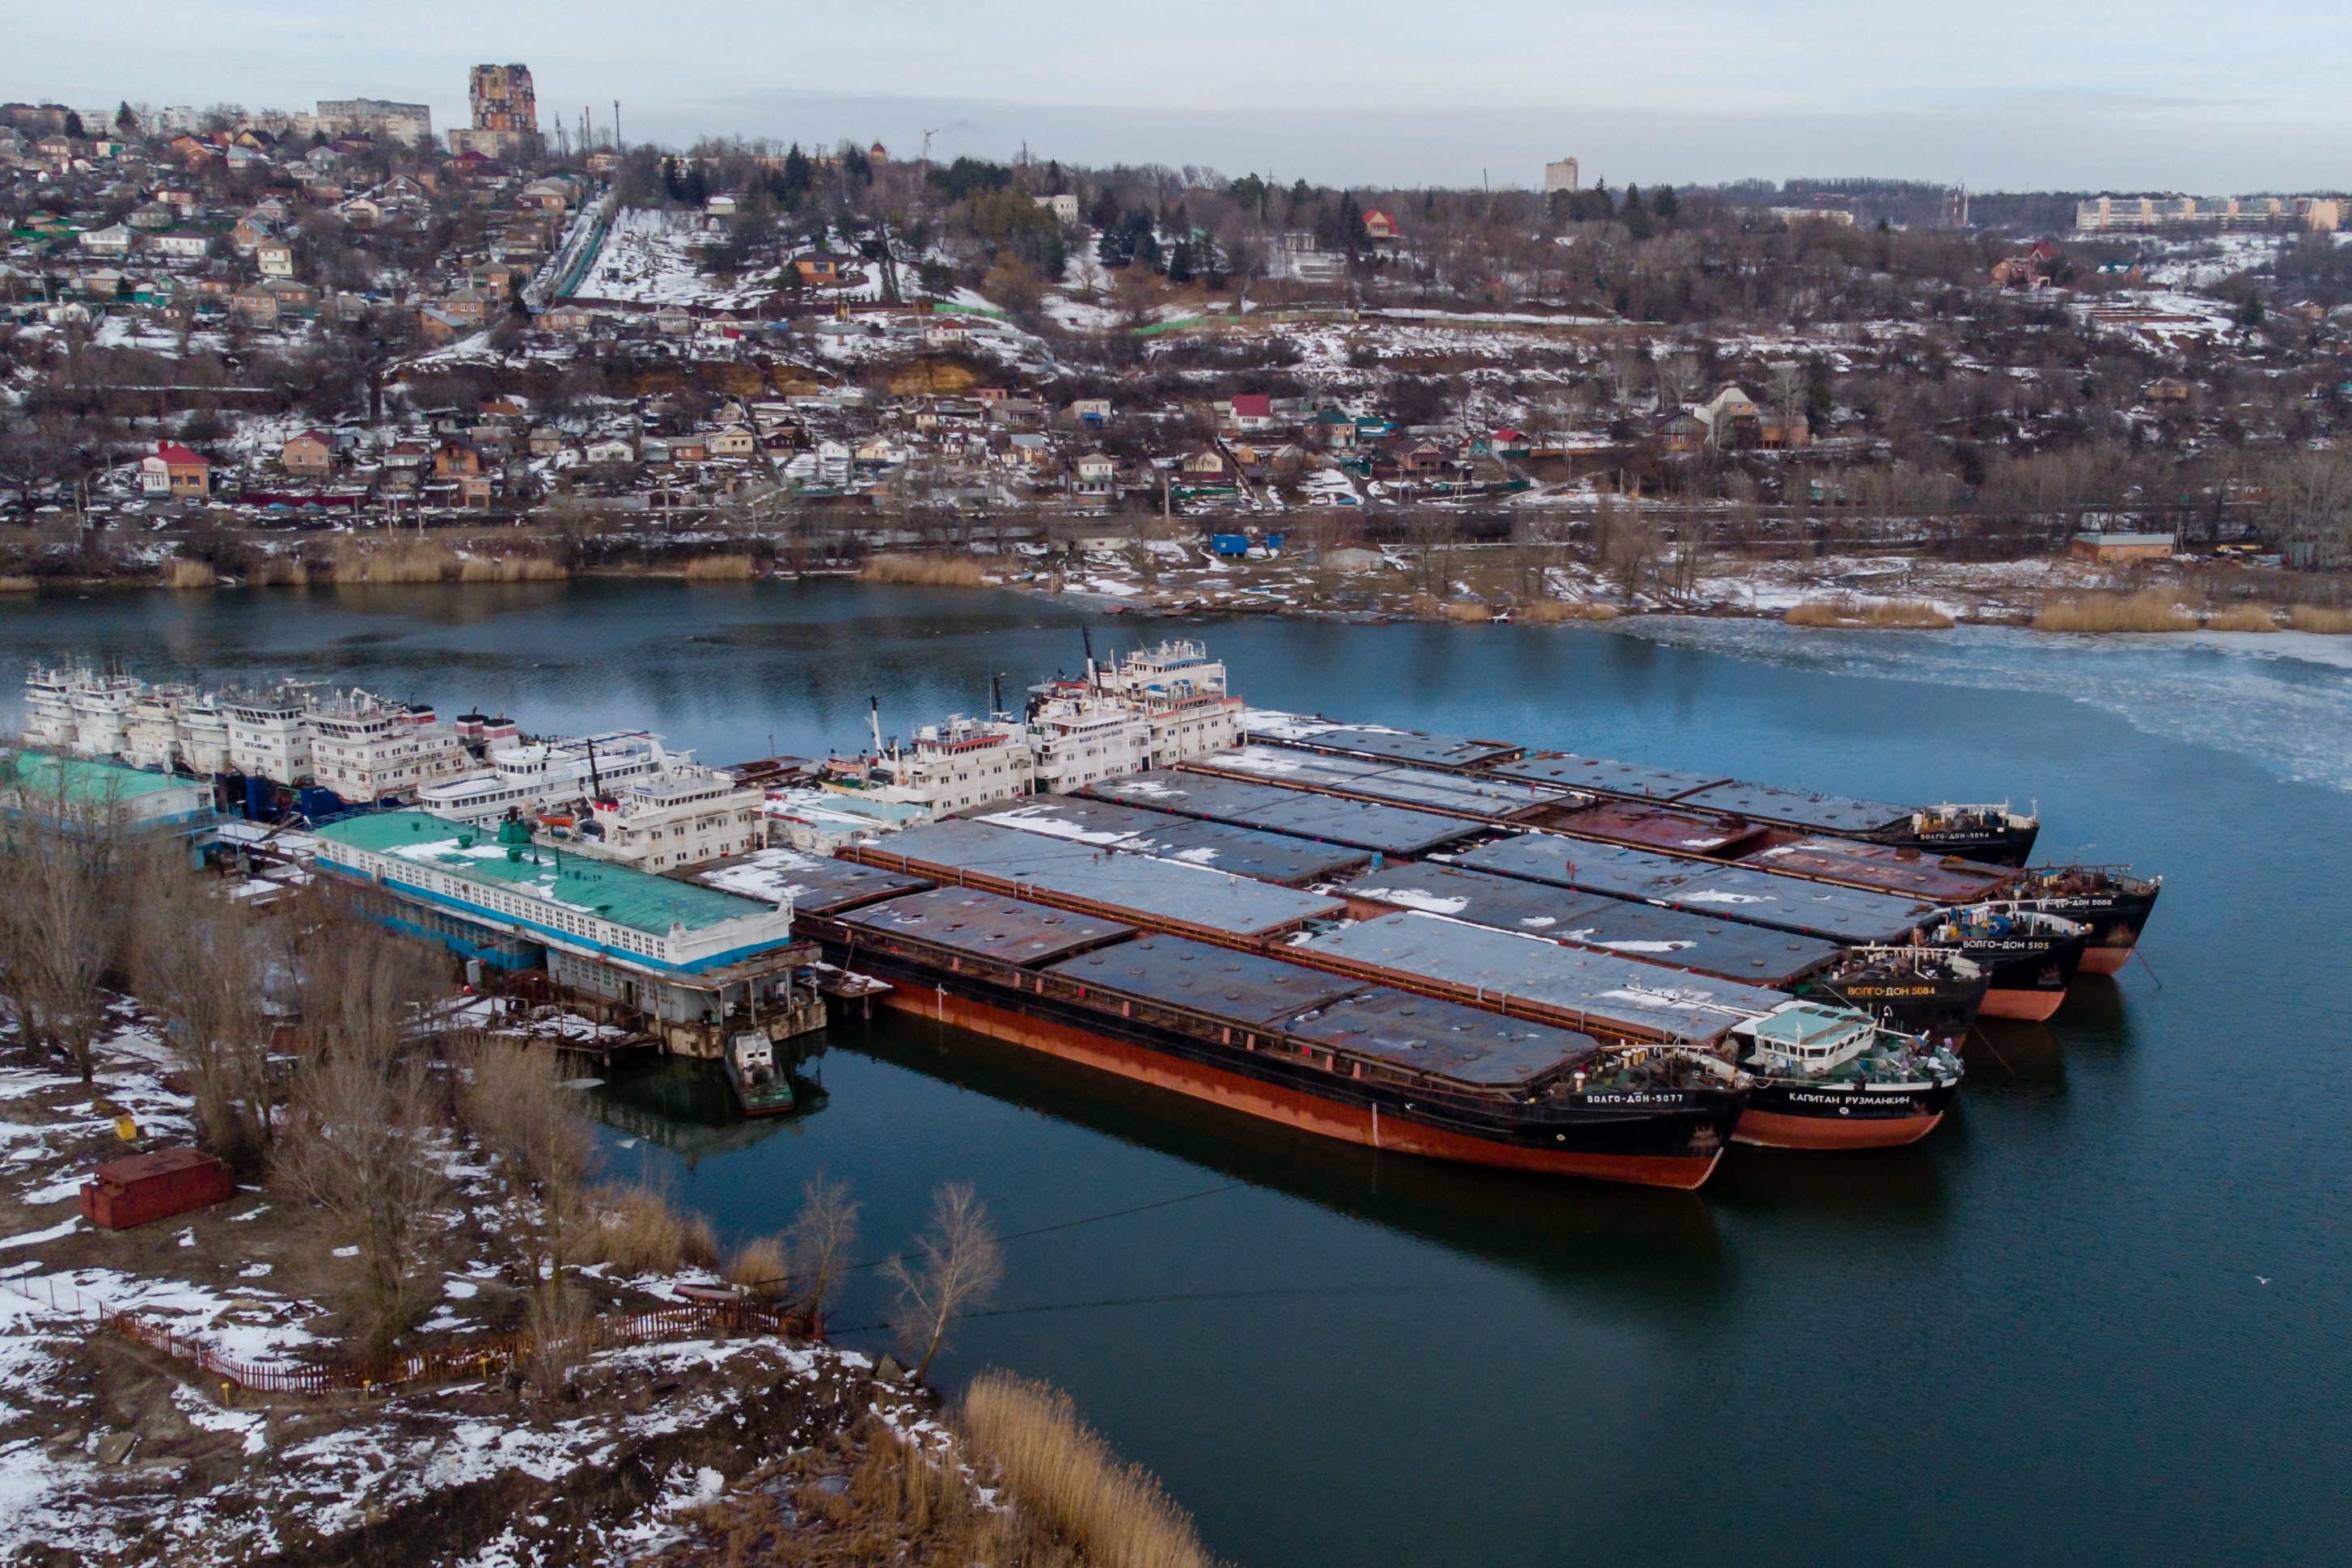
[802,886,1750,1190]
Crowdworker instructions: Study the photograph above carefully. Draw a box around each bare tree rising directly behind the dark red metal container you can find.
[132,844,277,1176]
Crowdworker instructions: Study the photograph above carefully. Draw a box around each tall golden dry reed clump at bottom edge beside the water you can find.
[962,1371,1209,1568]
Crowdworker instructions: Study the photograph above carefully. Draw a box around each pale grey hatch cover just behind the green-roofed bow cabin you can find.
[1287,910,1787,1049]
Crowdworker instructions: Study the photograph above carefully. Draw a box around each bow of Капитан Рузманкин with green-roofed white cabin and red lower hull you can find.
[1728,1001,1961,1150]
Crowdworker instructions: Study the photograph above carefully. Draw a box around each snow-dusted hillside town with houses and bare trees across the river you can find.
[0,63,2352,614]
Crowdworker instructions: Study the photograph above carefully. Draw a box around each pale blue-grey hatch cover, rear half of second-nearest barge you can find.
[844,818,1345,940]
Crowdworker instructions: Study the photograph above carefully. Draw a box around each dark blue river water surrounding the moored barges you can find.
[0,583,2352,1568]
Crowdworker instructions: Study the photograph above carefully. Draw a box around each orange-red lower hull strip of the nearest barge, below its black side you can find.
[882,987,1722,1192]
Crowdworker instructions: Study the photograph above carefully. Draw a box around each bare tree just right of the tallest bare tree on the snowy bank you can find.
[454,1037,595,1345]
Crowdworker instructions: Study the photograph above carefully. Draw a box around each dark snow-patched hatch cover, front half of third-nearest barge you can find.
[1331,863,1844,987]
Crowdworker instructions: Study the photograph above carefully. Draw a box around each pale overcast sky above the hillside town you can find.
[18,0,2352,195]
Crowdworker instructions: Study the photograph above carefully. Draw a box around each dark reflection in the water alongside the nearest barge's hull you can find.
[832,1013,1731,1312]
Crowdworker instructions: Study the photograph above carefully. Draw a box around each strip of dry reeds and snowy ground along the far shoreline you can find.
[14,536,2352,635]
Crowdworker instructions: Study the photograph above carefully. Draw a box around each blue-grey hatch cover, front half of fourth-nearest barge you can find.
[1446,832,1938,945]
